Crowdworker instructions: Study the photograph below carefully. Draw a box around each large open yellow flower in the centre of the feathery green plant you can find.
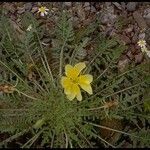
[61,62,93,101]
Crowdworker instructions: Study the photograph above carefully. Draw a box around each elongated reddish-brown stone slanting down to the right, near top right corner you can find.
[133,11,147,30]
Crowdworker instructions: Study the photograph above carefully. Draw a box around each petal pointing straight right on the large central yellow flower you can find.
[78,74,93,84]
